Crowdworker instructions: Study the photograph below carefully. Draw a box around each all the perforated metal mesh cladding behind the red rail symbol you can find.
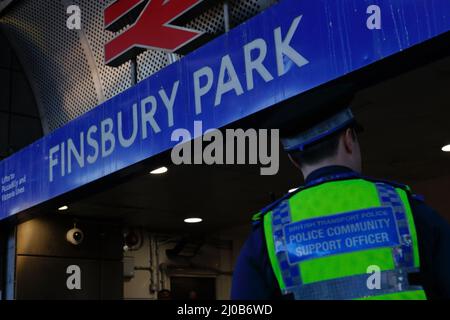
[0,0,275,130]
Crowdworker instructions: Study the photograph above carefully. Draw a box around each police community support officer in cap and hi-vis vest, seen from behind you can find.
[232,109,450,299]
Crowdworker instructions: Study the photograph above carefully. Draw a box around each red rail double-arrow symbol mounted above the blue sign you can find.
[105,0,205,66]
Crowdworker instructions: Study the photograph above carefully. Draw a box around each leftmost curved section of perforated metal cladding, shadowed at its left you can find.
[1,0,98,130]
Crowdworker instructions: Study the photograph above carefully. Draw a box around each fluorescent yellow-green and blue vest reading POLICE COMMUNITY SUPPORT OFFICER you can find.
[256,177,426,300]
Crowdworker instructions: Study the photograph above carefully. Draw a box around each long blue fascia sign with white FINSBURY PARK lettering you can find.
[0,0,450,220]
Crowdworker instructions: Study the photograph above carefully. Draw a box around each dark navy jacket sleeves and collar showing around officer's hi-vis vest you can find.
[231,166,450,300]
